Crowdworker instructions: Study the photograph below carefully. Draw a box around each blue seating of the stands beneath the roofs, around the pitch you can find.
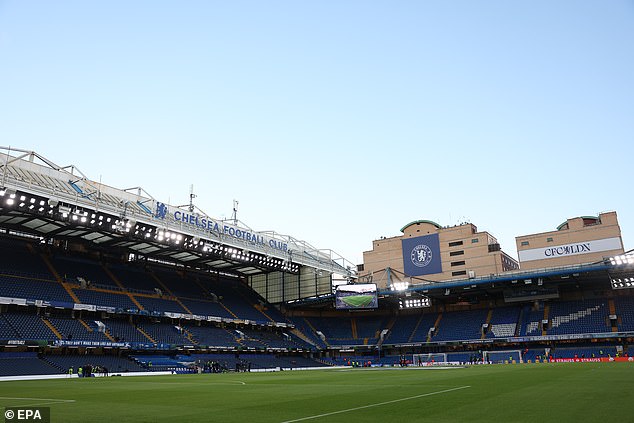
[0,234,634,376]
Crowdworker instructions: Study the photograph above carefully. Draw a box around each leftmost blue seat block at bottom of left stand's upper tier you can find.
[0,275,73,303]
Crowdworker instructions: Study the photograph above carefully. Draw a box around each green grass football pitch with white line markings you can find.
[0,363,634,423]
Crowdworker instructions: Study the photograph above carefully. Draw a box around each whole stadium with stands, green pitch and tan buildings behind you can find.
[0,147,634,422]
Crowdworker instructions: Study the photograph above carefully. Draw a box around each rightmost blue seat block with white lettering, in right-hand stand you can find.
[547,299,611,335]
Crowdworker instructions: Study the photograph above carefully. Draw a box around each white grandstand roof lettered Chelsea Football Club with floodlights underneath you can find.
[0,147,355,277]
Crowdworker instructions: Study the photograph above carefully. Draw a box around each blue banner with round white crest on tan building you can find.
[402,234,442,276]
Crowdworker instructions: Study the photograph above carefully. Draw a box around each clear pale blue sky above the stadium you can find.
[0,0,634,263]
